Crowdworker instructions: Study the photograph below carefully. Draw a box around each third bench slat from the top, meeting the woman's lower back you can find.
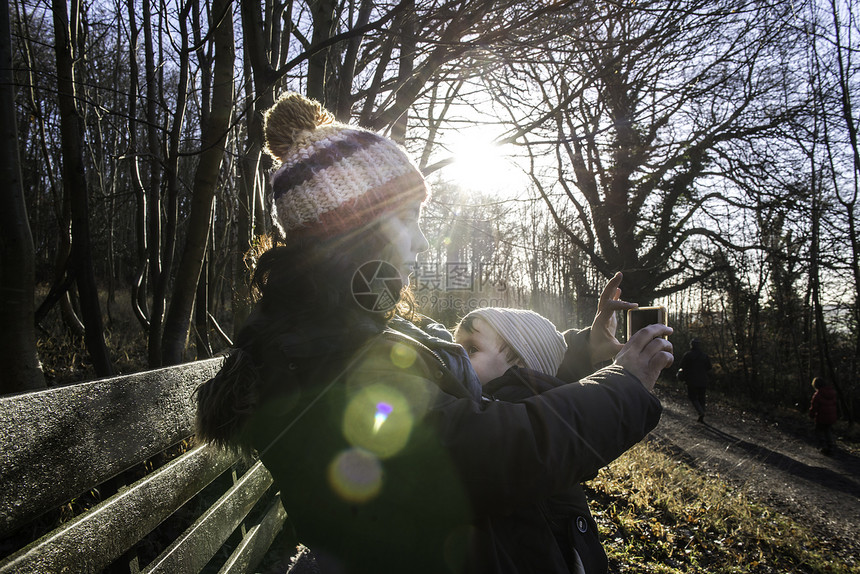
[143,462,272,574]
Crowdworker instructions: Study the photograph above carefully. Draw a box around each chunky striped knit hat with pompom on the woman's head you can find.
[263,93,427,239]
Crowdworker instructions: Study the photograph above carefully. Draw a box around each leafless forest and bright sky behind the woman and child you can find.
[0,0,860,418]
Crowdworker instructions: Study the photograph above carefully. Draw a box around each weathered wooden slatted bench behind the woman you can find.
[0,359,286,574]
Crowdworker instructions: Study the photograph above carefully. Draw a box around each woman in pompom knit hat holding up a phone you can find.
[197,94,672,573]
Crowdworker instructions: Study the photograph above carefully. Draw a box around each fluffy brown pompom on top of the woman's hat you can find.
[263,92,334,162]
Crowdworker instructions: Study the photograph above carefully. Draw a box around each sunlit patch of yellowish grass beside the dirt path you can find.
[586,443,860,574]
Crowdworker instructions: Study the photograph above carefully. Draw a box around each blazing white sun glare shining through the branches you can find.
[440,126,527,196]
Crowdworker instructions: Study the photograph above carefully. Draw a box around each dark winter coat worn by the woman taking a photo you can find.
[246,319,661,574]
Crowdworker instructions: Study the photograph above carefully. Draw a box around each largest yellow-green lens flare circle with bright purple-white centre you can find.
[343,384,414,459]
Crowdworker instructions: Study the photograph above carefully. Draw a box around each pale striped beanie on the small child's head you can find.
[463,307,567,376]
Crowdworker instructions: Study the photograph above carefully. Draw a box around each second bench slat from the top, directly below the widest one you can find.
[0,445,236,574]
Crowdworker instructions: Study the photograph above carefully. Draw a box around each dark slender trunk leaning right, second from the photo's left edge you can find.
[52,0,113,376]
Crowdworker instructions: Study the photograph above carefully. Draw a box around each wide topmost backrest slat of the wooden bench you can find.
[0,358,223,538]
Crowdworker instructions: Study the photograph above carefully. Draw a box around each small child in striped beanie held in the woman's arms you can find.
[454,307,632,574]
